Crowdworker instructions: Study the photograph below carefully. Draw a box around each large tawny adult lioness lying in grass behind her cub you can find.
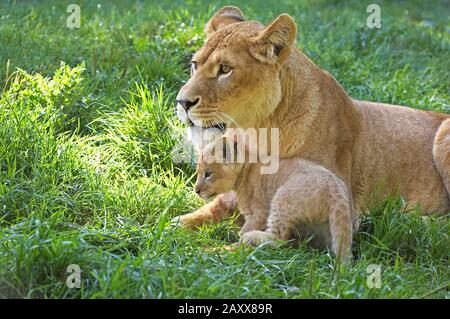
[173,7,450,227]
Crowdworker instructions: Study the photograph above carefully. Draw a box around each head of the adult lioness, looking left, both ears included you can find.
[177,7,297,128]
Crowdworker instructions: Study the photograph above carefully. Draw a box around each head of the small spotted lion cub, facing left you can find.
[194,136,245,201]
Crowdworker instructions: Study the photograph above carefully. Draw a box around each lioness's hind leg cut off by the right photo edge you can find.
[433,119,450,201]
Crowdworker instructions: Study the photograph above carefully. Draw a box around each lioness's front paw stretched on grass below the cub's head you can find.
[173,192,237,228]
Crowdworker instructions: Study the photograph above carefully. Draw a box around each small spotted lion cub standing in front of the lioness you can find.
[195,136,356,261]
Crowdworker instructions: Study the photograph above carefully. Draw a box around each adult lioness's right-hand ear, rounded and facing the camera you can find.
[250,14,297,63]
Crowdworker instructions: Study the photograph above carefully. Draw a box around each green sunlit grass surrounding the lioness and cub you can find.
[0,0,450,298]
